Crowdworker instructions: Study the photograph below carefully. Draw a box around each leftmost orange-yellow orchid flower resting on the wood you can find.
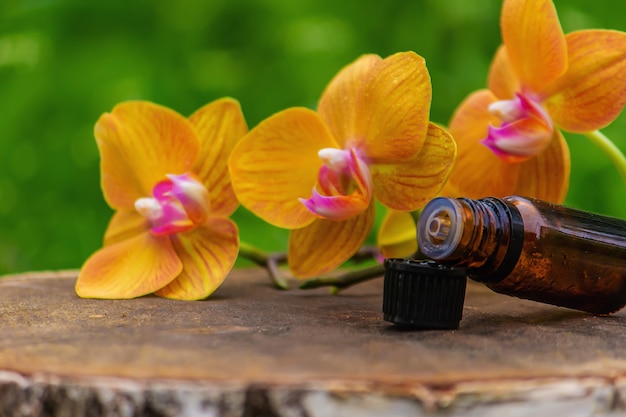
[75,98,248,300]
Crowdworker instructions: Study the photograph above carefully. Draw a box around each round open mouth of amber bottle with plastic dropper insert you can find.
[417,197,463,260]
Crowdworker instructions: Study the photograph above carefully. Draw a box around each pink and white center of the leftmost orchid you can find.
[135,174,210,235]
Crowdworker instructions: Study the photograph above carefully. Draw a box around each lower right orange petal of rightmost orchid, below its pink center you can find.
[512,130,570,203]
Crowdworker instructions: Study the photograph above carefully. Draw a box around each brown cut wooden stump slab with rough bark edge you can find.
[0,269,626,417]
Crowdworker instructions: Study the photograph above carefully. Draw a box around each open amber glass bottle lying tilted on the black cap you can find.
[418,196,626,314]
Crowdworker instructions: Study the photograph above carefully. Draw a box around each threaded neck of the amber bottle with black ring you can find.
[418,197,524,282]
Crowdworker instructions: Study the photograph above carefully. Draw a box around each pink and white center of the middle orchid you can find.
[300,148,373,221]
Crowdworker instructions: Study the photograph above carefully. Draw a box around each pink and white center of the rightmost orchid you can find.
[482,93,554,162]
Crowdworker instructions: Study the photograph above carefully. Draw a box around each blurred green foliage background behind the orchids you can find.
[0,0,626,273]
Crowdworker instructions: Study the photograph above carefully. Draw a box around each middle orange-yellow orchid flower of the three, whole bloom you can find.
[229,52,456,278]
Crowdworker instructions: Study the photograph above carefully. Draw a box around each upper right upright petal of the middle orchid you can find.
[356,52,432,161]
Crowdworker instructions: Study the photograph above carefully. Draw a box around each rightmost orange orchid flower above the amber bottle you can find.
[444,0,626,202]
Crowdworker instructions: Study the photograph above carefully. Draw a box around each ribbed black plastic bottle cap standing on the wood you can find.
[383,259,467,329]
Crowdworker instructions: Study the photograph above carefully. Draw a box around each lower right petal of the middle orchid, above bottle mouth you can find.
[371,123,456,210]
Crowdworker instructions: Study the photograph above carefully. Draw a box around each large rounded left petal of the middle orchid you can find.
[229,108,337,229]
